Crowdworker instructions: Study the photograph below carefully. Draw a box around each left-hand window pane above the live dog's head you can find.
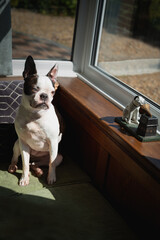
[11,0,77,60]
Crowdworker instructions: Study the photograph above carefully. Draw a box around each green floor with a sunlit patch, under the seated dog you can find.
[0,158,138,240]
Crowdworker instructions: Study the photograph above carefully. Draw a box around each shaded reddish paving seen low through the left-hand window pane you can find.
[12,31,71,60]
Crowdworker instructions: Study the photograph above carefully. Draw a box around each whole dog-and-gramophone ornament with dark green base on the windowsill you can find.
[115,96,160,142]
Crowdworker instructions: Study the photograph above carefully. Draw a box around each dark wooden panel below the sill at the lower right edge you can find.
[106,157,160,227]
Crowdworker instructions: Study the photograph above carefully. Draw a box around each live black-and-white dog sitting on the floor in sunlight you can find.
[8,56,63,186]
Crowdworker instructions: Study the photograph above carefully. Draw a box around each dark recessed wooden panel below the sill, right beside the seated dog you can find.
[63,109,99,178]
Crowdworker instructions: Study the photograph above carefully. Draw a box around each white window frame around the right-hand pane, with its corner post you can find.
[73,0,160,129]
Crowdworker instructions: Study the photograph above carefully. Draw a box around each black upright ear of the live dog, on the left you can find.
[23,56,37,78]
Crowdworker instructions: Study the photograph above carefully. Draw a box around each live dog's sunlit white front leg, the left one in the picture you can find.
[19,141,30,186]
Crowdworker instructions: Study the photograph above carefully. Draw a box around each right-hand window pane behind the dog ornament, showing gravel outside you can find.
[95,0,160,104]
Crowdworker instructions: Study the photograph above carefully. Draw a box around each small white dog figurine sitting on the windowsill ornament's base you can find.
[122,96,145,124]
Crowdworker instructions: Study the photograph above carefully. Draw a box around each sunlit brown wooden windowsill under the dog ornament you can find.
[58,77,160,182]
